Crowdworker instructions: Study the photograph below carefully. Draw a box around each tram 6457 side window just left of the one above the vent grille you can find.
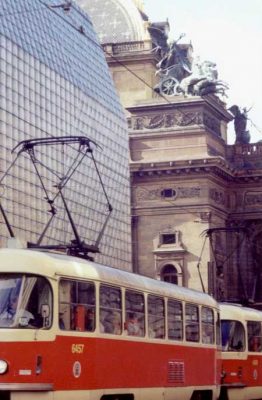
[147,295,165,339]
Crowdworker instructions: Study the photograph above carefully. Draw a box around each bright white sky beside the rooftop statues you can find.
[143,0,262,144]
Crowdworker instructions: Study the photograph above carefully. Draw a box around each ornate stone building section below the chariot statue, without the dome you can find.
[129,96,262,302]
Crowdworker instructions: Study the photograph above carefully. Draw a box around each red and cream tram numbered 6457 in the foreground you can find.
[0,249,221,400]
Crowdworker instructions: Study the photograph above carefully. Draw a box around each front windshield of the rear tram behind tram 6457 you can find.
[221,320,245,351]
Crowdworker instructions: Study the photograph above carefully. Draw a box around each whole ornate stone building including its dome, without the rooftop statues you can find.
[78,0,262,307]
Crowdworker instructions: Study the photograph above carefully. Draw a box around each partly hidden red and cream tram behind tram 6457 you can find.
[220,304,262,400]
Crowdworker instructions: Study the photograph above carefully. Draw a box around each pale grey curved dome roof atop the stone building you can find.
[77,0,149,43]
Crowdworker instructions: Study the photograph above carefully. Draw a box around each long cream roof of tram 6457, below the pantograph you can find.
[0,249,217,307]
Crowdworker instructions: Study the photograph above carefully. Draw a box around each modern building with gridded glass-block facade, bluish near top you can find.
[0,0,131,269]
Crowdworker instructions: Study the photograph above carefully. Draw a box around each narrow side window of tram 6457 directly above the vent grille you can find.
[167,300,183,340]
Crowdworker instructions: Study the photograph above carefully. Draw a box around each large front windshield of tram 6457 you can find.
[0,274,52,329]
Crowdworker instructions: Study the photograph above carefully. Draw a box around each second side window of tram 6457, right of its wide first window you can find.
[99,285,122,335]
